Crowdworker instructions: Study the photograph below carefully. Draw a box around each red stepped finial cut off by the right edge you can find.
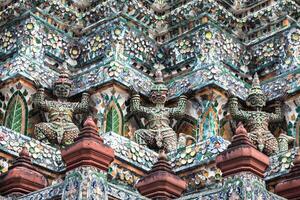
[275,150,300,199]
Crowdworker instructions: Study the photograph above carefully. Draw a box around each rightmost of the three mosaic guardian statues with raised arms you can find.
[229,74,283,155]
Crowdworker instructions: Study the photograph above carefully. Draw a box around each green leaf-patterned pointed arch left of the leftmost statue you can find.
[4,91,28,135]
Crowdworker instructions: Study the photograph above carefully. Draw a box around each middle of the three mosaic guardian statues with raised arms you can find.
[131,66,187,152]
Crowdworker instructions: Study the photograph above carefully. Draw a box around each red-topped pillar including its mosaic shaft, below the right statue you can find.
[216,123,277,200]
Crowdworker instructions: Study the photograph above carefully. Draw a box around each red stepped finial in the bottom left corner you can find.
[0,148,47,196]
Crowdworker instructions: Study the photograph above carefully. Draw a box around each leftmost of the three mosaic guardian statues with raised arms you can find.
[33,74,89,145]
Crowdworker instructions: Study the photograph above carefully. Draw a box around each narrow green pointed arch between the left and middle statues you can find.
[104,99,124,135]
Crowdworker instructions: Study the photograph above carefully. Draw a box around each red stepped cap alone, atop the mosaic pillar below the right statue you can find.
[216,123,269,178]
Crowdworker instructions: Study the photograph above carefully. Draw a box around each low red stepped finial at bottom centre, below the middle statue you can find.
[136,151,187,200]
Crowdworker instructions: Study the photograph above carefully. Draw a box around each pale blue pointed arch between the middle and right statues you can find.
[197,105,219,142]
